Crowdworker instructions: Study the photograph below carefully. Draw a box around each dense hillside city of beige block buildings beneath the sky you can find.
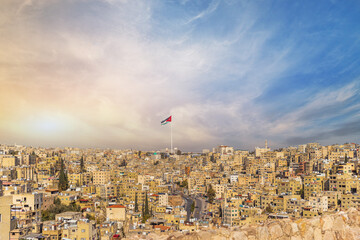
[0,142,360,240]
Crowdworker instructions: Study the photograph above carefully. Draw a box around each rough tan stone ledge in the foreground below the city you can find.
[126,208,360,240]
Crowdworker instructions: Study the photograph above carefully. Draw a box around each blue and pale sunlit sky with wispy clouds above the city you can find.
[0,0,360,151]
